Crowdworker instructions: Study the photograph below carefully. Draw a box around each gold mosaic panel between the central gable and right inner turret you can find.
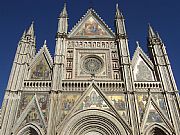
[108,95,127,119]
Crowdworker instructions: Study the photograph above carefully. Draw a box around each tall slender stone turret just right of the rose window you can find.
[115,4,139,135]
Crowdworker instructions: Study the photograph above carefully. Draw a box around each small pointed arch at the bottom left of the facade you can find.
[16,123,43,135]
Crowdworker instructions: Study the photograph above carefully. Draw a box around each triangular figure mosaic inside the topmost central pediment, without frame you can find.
[76,17,107,37]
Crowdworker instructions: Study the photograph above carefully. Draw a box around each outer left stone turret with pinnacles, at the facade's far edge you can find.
[0,23,36,135]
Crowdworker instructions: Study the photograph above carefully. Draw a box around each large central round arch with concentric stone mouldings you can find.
[58,110,129,135]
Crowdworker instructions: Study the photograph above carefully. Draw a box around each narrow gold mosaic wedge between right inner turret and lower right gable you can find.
[137,94,148,120]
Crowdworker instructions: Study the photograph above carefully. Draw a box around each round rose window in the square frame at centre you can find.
[82,56,103,74]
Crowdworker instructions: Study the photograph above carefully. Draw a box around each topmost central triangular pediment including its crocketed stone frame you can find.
[69,9,115,38]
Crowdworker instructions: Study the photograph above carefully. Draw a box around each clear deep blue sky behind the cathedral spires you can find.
[0,0,180,104]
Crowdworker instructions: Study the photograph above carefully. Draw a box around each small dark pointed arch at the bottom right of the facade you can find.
[145,124,172,135]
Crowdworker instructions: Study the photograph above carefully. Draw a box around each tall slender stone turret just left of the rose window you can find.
[47,3,68,135]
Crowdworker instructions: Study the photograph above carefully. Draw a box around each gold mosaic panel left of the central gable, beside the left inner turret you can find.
[61,94,80,120]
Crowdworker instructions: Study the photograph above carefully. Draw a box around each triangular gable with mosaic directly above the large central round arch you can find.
[58,82,129,128]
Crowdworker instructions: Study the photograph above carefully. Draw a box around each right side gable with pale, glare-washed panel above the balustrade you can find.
[132,46,155,81]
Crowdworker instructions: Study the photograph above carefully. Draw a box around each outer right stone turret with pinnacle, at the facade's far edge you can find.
[148,25,180,133]
